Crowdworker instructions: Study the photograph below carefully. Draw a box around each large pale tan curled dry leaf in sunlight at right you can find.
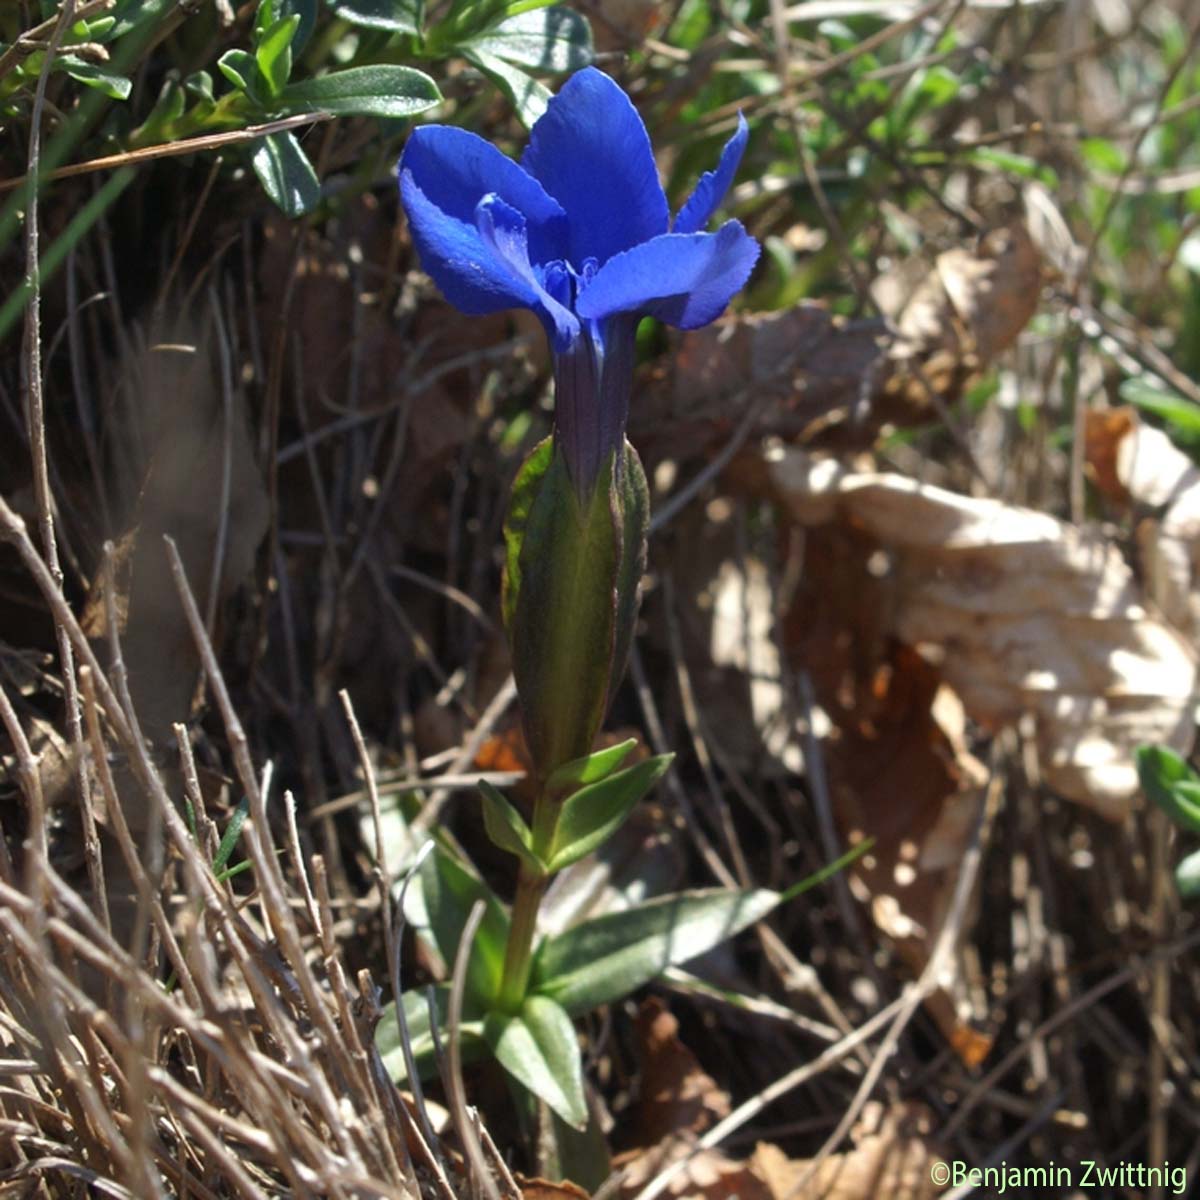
[772,451,1198,820]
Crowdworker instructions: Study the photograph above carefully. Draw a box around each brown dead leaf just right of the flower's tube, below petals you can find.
[630,223,1042,466]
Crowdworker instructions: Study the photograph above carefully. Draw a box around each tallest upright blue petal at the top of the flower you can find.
[521,67,670,270]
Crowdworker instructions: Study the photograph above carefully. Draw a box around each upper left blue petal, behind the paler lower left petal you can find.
[398,125,566,263]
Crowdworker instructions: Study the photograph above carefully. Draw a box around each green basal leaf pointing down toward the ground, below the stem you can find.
[484,996,588,1129]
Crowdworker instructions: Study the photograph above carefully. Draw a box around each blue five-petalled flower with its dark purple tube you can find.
[400,67,758,496]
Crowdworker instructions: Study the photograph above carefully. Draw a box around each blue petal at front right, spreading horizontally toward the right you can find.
[575,221,758,329]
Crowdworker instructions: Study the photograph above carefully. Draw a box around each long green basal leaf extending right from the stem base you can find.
[529,888,780,1015]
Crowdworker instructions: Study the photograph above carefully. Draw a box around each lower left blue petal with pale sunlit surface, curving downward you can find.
[400,170,577,345]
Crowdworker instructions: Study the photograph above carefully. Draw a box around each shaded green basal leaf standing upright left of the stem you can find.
[419,846,509,1008]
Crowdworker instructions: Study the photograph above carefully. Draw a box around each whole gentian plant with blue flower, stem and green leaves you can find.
[379,67,835,1171]
